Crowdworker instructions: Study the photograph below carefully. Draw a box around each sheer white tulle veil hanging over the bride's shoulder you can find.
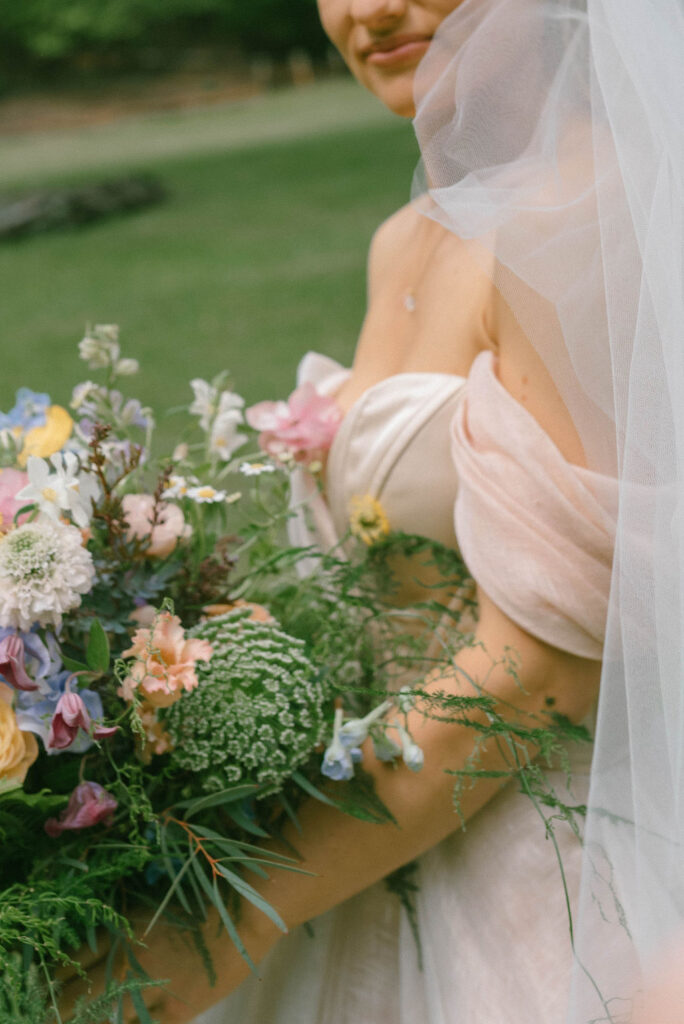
[415,0,684,1024]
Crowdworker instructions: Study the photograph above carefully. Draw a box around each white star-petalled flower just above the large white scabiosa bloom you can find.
[16,452,99,527]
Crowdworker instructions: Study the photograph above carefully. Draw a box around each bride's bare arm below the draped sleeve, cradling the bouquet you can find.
[77,594,600,1024]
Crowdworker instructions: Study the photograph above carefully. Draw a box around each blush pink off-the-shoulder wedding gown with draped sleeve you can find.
[196,353,615,1024]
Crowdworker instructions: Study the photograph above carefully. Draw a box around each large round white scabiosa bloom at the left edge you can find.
[0,516,95,631]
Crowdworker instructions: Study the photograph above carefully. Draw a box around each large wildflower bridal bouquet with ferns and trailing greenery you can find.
[0,326,458,1024]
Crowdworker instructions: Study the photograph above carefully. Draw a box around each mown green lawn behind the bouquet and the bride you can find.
[0,81,417,446]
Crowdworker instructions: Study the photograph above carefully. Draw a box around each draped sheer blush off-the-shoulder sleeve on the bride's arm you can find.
[452,352,617,658]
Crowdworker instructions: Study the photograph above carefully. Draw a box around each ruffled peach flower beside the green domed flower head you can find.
[119,611,213,708]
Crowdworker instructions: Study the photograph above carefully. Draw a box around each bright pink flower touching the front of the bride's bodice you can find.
[245,382,342,464]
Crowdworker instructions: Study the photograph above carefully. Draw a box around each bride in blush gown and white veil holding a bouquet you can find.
[68,0,684,1024]
